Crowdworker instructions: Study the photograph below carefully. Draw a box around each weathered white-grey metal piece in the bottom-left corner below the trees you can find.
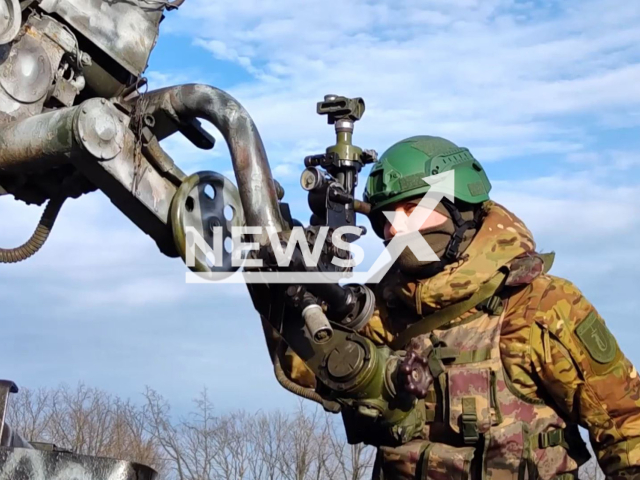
[0,448,156,480]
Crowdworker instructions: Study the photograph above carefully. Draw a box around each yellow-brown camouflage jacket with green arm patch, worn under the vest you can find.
[282,202,640,479]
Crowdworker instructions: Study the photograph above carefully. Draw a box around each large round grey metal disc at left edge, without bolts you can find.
[0,33,53,103]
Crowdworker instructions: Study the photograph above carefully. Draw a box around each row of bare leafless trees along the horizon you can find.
[9,384,373,480]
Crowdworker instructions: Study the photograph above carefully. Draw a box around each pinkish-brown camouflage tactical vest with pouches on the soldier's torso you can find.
[373,258,589,480]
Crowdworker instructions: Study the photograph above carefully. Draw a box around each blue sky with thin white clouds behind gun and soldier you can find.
[0,0,640,410]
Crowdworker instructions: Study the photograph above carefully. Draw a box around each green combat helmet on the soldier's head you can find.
[364,135,491,237]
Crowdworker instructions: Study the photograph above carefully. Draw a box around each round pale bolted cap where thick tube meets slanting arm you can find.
[77,98,124,160]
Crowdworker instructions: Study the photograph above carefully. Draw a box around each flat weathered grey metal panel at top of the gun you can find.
[40,0,164,76]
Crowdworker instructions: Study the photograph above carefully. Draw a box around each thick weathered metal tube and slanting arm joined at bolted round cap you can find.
[0,93,177,256]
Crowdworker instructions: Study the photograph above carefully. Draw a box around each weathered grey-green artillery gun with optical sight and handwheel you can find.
[0,0,436,480]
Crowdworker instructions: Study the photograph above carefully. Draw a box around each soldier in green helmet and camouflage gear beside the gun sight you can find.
[289,136,640,480]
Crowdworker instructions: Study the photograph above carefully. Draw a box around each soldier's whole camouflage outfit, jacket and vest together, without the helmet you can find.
[289,202,640,480]
